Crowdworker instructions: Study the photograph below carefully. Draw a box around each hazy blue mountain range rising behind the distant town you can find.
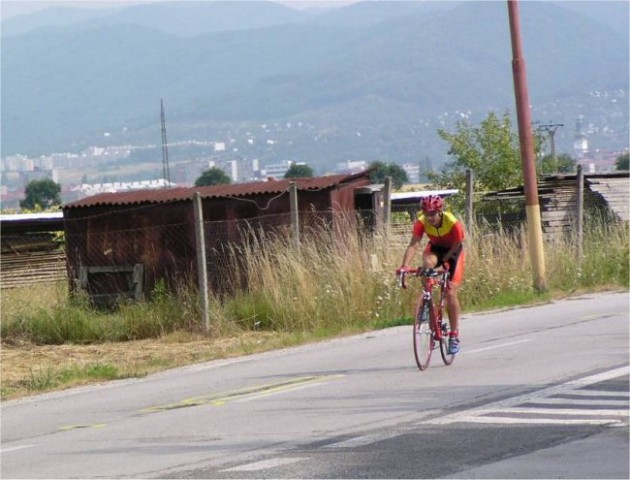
[1,1,629,170]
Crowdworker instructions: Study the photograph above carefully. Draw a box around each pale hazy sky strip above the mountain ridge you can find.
[0,0,357,18]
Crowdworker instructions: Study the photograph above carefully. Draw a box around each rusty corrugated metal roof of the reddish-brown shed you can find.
[63,171,369,209]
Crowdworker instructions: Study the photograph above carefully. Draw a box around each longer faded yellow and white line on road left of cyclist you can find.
[140,375,343,412]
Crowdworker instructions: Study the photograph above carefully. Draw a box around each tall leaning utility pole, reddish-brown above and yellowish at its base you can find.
[507,0,547,292]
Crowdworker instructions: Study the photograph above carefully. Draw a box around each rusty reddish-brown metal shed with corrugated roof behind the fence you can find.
[63,172,377,298]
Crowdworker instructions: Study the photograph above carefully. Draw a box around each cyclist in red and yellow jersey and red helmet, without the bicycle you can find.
[396,195,466,355]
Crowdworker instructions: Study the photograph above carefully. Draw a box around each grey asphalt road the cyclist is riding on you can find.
[0,292,630,479]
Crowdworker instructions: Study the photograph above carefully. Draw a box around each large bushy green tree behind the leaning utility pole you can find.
[428,112,542,191]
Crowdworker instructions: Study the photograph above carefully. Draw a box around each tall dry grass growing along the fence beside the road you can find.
[1,216,629,343]
